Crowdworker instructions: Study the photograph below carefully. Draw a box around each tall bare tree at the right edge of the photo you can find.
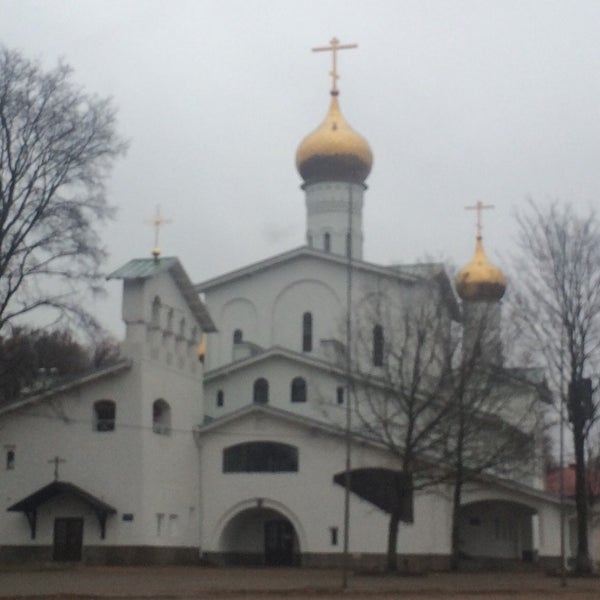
[511,201,600,572]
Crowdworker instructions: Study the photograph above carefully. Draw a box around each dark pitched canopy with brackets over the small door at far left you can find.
[6,481,117,540]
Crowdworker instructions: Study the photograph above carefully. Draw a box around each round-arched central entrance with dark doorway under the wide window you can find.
[220,506,300,567]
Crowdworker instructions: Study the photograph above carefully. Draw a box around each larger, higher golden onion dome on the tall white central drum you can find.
[296,92,373,183]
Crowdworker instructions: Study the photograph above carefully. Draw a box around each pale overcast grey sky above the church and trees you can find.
[0,0,600,332]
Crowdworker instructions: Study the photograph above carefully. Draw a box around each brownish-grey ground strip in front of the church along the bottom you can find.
[0,566,600,600]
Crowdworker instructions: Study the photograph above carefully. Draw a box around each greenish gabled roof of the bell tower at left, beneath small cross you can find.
[107,256,217,333]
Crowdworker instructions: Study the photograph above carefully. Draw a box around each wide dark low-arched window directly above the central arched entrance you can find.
[223,442,298,473]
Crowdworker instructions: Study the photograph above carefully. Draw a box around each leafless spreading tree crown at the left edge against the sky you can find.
[0,47,125,330]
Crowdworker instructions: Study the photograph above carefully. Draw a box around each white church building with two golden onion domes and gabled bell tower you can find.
[0,50,568,568]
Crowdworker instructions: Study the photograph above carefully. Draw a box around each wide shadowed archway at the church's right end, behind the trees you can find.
[460,500,537,561]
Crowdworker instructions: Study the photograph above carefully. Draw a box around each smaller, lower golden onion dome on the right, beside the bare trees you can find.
[454,237,506,302]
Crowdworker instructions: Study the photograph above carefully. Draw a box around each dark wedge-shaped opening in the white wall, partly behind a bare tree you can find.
[333,467,413,523]
